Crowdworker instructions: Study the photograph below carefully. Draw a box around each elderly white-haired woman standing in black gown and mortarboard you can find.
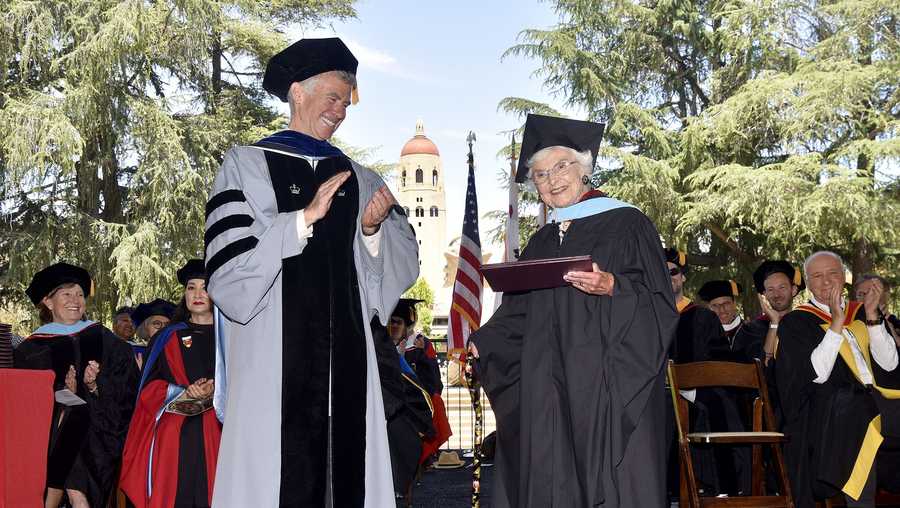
[470,115,678,508]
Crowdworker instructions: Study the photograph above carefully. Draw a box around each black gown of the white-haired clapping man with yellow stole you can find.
[775,302,900,508]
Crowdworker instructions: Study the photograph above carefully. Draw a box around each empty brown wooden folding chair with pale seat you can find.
[668,360,794,508]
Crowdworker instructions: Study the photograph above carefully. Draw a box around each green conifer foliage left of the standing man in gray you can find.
[0,0,355,330]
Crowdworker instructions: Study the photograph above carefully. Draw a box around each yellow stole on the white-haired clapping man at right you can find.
[797,302,900,499]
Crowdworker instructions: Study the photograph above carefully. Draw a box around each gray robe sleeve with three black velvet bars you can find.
[204,147,306,324]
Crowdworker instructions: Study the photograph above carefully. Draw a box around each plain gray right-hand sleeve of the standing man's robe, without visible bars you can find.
[353,163,419,325]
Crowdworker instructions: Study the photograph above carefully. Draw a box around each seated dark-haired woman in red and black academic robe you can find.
[120,259,221,508]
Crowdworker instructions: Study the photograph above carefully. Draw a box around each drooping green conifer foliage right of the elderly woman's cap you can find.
[500,0,900,310]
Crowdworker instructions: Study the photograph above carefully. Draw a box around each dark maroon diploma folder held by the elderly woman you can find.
[481,256,594,293]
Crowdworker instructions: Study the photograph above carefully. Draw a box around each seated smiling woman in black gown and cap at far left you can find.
[15,263,140,508]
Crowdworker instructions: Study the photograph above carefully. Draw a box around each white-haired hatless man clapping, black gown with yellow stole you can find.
[775,251,900,508]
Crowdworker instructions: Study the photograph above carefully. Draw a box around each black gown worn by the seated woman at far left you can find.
[15,323,140,506]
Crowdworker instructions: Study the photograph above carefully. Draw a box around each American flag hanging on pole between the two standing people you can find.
[448,159,484,362]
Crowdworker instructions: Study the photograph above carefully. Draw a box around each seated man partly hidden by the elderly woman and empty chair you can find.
[665,248,746,494]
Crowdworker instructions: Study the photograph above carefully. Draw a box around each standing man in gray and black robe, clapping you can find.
[205,38,418,508]
